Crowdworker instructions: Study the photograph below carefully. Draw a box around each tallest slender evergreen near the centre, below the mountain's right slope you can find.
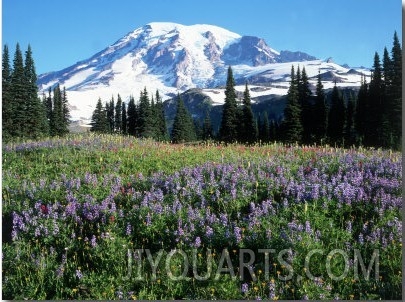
[219,66,238,143]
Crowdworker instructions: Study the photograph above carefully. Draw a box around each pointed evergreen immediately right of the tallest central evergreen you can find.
[240,83,257,144]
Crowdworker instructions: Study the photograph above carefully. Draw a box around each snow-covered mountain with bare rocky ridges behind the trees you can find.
[38,22,370,120]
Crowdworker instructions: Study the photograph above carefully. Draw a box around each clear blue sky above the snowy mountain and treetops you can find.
[2,0,402,74]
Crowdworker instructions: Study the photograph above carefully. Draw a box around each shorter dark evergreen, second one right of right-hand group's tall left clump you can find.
[328,82,346,145]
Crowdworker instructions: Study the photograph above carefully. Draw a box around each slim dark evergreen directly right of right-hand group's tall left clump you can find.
[312,72,328,143]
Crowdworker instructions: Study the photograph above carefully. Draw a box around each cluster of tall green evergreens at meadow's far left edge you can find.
[2,43,70,141]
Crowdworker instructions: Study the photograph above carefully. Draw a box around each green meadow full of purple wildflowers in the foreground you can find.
[2,134,402,300]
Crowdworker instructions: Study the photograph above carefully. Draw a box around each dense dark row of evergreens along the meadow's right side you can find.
[281,33,402,150]
